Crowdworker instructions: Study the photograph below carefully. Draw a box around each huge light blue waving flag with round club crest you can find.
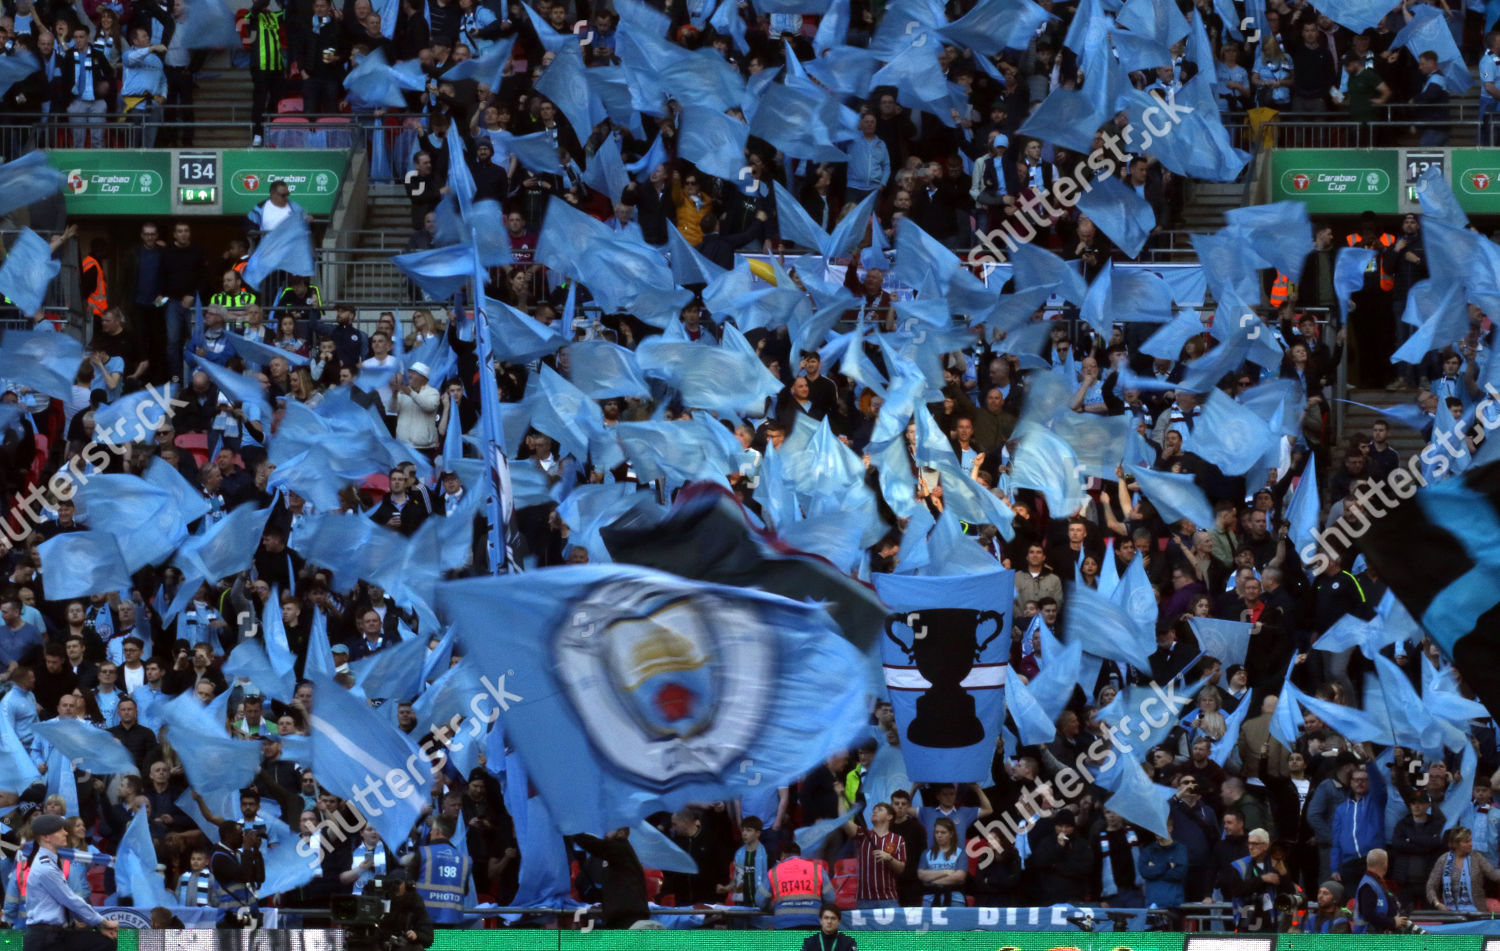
[438,566,869,834]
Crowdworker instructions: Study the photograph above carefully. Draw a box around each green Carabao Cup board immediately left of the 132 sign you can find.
[1271,149,1401,215]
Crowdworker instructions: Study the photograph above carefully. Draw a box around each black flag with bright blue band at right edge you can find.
[1368,456,1500,717]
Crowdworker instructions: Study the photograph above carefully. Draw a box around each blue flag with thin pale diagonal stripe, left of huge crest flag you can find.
[309,668,432,842]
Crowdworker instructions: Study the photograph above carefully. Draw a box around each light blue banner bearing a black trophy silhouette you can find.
[875,570,1016,785]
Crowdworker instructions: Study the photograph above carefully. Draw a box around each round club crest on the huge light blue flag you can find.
[555,585,776,782]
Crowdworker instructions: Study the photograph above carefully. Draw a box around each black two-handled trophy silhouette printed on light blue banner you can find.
[885,608,1004,749]
